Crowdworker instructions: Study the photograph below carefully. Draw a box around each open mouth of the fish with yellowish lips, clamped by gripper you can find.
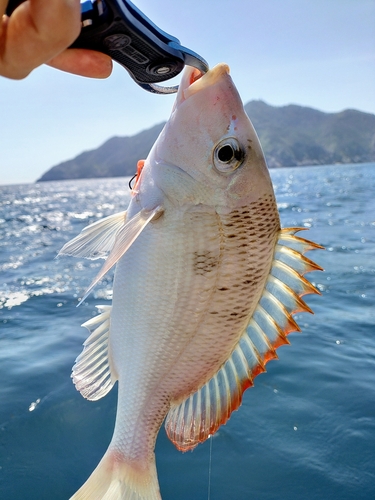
[177,63,230,104]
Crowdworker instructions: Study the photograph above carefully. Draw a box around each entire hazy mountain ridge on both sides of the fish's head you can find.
[37,101,375,182]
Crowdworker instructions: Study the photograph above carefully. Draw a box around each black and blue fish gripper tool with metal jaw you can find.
[6,0,208,94]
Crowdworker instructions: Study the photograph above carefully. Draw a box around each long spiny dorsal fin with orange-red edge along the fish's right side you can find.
[165,228,322,451]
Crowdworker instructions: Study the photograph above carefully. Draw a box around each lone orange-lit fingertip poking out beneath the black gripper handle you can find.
[47,49,112,78]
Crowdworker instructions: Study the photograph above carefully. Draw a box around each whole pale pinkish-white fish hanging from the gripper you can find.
[60,63,322,500]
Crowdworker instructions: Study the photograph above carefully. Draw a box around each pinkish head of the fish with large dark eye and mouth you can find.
[151,64,273,211]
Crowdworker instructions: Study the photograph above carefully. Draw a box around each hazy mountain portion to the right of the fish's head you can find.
[245,101,375,167]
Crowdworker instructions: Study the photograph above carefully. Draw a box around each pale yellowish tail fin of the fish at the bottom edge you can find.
[70,450,161,500]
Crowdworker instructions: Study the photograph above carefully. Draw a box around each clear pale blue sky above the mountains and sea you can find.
[0,0,375,184]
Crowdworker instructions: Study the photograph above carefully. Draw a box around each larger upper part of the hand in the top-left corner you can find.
[0,0,81,79]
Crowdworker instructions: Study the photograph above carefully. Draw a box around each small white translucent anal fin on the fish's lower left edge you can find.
[72,306,117,401]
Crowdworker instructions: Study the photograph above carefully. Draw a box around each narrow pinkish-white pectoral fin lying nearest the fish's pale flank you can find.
[78,207,163,305]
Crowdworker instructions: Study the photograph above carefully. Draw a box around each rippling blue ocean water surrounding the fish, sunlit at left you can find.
[0,164,375,500]
